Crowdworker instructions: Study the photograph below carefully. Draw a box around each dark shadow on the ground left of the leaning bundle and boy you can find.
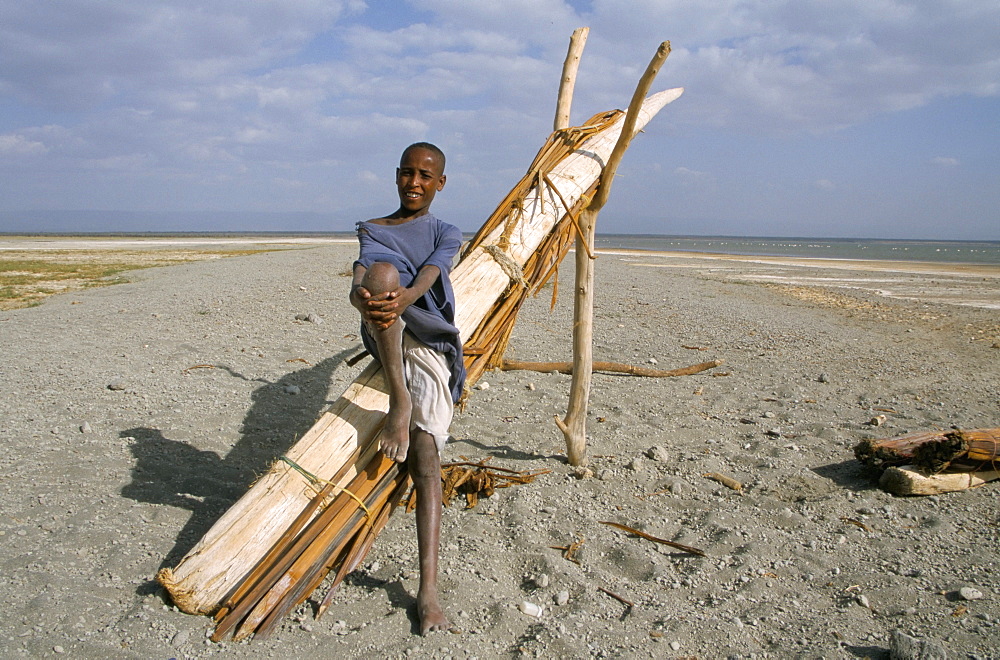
[120,347,357,568]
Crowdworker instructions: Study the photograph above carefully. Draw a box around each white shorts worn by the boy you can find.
[403,330,455,453]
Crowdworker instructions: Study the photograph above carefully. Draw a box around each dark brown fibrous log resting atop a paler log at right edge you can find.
[854,428,1000,474]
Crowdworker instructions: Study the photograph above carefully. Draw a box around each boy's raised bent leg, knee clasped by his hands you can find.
[361,261,412,463]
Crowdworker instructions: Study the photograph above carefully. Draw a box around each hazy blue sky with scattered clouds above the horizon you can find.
[0,0,1000,240]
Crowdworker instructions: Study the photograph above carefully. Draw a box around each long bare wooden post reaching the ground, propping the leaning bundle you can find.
[556,41,670,466]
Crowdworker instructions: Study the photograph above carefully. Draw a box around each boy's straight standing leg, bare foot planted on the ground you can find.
[406,428,451,635]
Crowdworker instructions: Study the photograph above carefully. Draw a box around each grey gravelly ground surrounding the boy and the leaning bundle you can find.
[0,244,1000,659]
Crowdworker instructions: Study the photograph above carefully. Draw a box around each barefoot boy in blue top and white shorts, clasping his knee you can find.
[350,142,465,635]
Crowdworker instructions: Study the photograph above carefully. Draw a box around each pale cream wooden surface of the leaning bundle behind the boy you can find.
[158,89,683,614]
